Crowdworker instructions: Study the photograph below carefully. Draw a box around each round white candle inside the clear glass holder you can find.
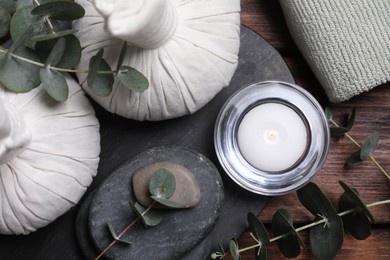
[237,103,308,172]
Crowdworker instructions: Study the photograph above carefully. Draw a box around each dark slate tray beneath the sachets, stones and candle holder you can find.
[0,26,294,260]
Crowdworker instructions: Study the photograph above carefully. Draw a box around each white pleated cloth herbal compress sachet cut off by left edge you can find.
[0,77,100,234]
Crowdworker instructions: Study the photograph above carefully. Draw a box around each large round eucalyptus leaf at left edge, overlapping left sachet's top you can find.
[0,47,41,93]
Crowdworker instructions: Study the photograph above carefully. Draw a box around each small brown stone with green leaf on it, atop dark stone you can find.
[133,162,200,208]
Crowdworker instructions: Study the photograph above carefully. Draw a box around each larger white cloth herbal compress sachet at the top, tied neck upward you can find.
[73,0,240,120]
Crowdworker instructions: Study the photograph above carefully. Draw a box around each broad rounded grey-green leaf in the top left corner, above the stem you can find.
[10,6,45,48]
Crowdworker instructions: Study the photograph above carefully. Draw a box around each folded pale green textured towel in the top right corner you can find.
[279,0,390,102]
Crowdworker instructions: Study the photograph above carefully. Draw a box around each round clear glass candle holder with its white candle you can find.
[214,81,330,196]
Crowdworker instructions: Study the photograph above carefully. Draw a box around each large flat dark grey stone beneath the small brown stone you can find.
[89,146,224,260]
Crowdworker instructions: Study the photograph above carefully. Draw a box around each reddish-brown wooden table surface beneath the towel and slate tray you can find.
[238,0,390,260]
